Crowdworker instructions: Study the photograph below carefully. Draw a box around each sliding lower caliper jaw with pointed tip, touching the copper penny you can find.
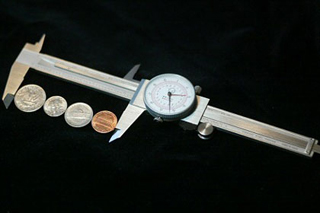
[109,79,149,143]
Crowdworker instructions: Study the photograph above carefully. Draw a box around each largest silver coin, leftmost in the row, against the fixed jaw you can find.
[14,84,46,112]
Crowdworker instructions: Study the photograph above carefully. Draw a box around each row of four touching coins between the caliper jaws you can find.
[14,84,118,133]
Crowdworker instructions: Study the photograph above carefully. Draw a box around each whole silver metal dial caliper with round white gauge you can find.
[2,36,320,157]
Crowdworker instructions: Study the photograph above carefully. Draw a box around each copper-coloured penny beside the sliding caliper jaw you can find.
[91,110,118,133]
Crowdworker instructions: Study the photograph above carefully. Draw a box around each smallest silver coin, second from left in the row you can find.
[43,96,68,117]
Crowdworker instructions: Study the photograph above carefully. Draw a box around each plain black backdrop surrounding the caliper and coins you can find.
[0,0,320,212]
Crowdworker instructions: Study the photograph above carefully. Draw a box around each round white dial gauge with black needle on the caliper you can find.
[144,74,196,120]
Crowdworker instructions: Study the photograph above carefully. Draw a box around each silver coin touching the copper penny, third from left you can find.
[64,102,93,127]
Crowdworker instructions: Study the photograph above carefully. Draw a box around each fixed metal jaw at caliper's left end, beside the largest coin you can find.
[2,35,45,109]
